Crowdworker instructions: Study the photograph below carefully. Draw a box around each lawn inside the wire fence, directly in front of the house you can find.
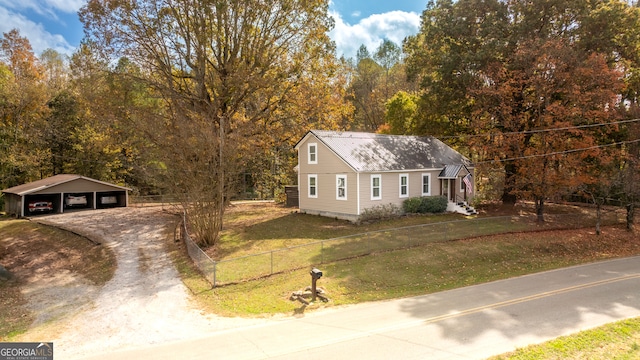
[210,208,616,285]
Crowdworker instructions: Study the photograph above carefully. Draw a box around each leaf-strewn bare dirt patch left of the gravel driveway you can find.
[0,219,115,339]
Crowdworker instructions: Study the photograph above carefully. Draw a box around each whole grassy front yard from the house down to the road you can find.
[173,204,639,316]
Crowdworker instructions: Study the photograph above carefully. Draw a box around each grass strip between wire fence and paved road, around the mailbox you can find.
[172,217,640,316]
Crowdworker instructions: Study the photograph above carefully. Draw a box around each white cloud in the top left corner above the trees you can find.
[0,6,75,56]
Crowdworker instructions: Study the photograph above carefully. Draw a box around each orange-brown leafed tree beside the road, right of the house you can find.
[471,40,623,220]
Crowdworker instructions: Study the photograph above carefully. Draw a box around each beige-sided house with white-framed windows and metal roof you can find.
[295,130,474,221]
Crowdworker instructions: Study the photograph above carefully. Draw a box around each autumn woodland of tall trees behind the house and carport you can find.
[0,0,640,245]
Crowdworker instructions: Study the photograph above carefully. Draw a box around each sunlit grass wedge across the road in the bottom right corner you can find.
[491,318,640,360]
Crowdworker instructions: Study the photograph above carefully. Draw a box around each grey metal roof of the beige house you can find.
[308,130,471,172]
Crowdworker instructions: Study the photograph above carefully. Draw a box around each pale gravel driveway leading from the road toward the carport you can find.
[30,208,265,359]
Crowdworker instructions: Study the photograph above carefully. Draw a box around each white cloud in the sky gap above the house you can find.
[329,11,420,58]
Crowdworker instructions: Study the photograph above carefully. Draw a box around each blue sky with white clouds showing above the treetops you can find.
[0,0,428,57]
